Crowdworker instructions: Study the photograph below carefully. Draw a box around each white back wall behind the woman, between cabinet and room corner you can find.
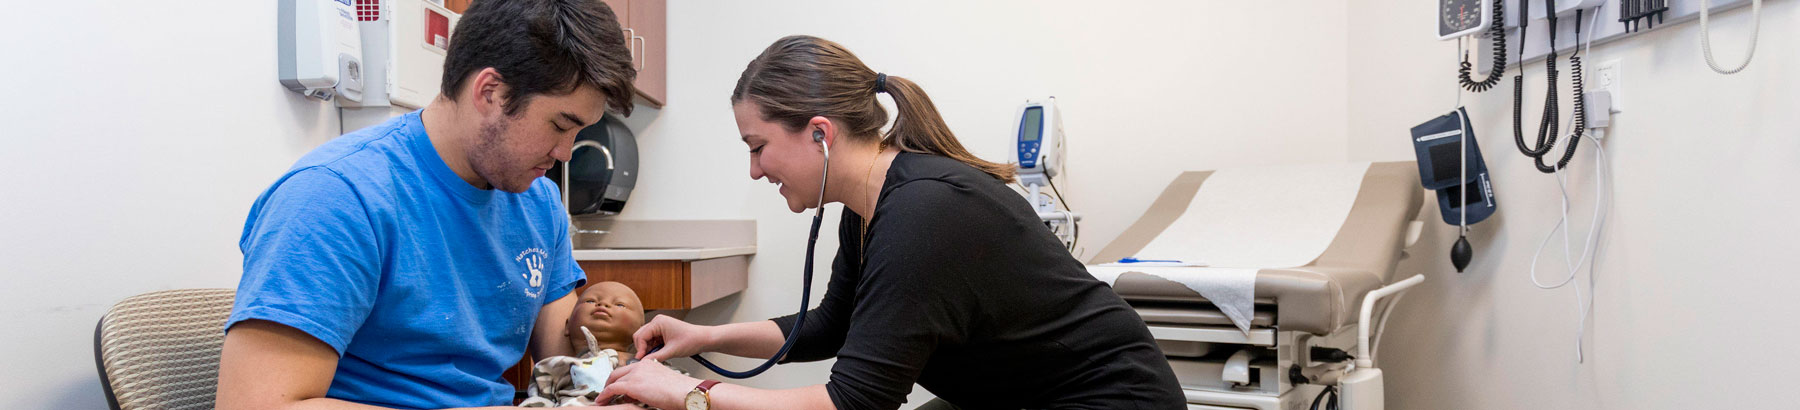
[621,0,1346,405]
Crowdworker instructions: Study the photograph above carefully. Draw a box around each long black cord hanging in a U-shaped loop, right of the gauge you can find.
[1512,0,1588,174]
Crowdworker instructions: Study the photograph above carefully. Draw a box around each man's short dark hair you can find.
[443,0,637,115]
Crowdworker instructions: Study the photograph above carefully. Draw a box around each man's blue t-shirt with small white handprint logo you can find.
[225,111,585,408]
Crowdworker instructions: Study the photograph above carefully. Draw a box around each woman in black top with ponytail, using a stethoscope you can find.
[603,36,1184,410]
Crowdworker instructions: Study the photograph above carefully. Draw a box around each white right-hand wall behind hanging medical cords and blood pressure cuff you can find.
[1345,0,1800,410]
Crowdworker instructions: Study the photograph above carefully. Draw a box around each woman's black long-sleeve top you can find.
[774,153,1184,410]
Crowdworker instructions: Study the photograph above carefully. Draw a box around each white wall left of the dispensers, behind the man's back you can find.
[0,2,351,408]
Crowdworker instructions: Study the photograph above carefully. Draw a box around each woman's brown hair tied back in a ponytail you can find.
[731,36,1017,182]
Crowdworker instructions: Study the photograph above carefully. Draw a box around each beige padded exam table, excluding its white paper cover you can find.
[1089,162,1424,410]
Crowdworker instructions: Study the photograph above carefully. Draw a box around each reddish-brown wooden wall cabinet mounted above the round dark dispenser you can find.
[605,0,668,108]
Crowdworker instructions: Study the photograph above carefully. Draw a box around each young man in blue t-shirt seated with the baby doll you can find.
[218,0,635,410]
